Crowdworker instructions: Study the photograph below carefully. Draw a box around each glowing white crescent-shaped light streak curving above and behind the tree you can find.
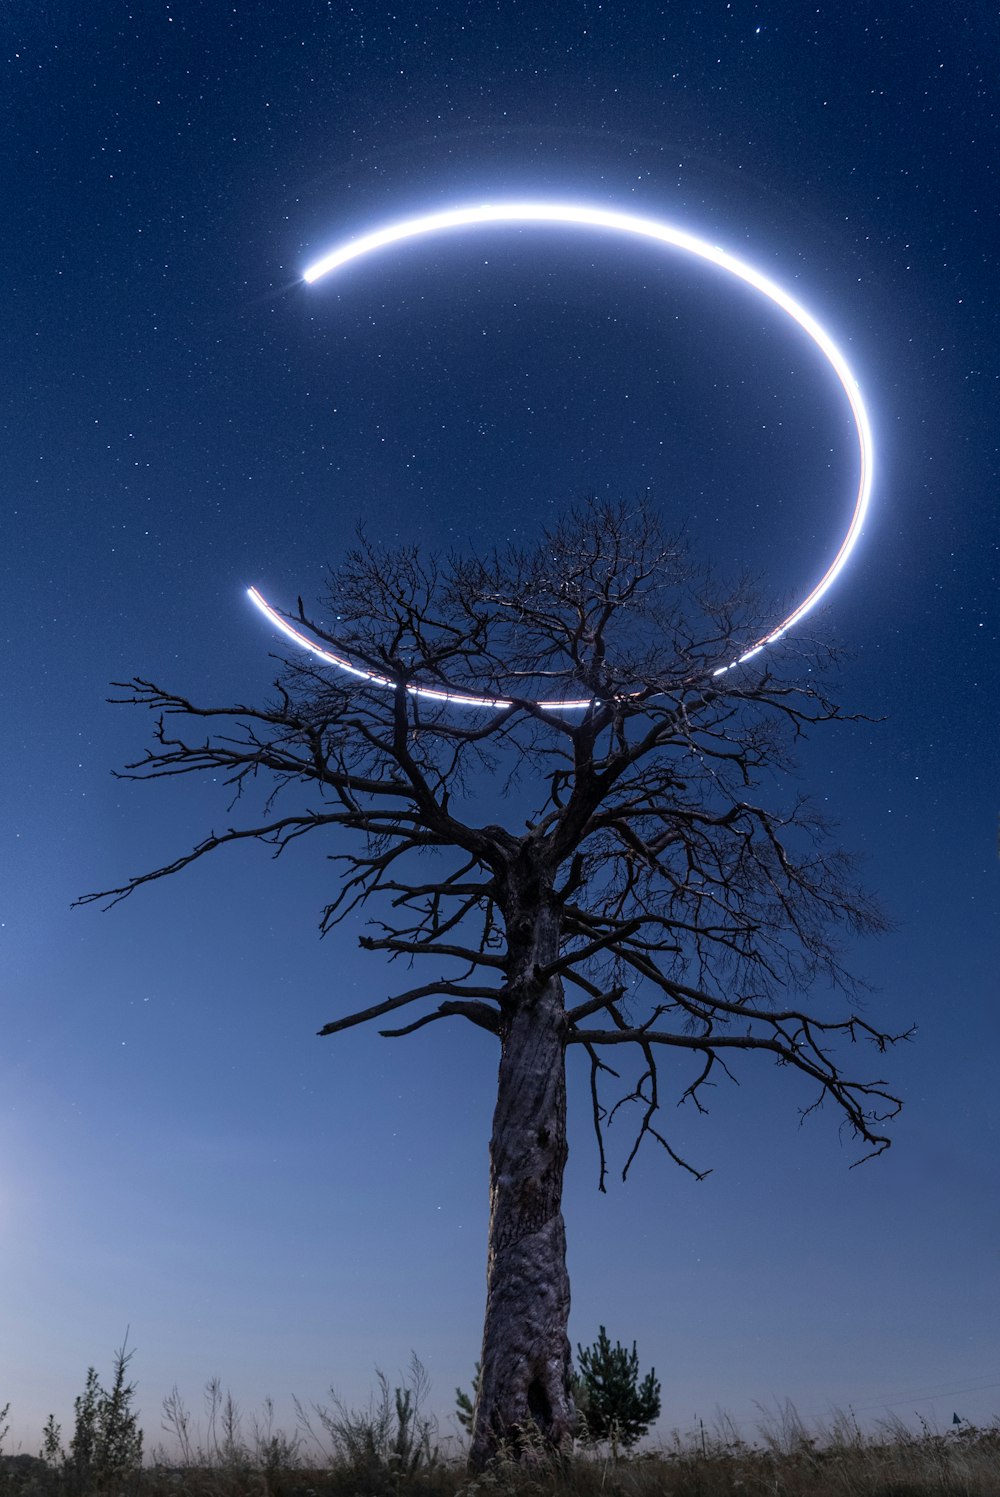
[249,202,874,711]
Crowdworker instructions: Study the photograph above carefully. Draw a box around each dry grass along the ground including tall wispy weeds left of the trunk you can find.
[0,1362,1000,1497]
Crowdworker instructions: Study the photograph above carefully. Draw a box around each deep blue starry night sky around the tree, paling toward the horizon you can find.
[0,0,1000,1451]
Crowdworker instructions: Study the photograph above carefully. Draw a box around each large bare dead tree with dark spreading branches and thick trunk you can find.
[81,501,900,1469]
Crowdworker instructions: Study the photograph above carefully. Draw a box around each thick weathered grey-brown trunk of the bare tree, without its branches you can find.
[469,906,575,1470]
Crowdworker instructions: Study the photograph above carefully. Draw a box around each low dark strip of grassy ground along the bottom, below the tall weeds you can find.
[7,1409,1000,1497]
